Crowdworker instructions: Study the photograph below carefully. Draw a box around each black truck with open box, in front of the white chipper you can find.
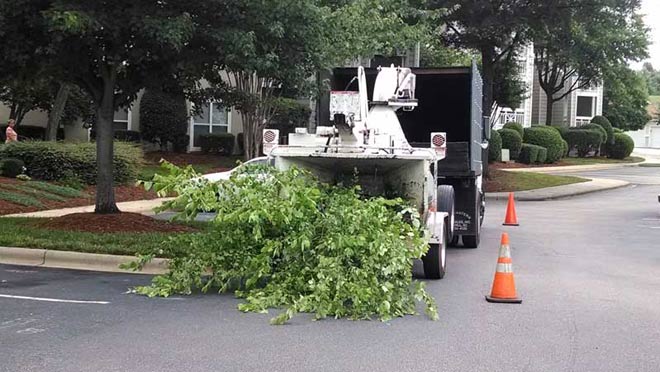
[319,65,488,248]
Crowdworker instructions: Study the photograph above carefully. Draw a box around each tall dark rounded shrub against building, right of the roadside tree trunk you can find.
[140,89,188,151]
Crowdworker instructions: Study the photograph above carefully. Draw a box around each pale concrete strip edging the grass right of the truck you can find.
[486,178,630,201]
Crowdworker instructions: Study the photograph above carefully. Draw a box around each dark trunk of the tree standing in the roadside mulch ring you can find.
[94,77,119,213]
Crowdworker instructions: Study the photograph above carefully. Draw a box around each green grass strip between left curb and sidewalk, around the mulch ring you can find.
[0,218,209,256]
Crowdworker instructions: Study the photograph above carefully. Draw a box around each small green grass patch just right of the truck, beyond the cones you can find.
[485,169,589,192]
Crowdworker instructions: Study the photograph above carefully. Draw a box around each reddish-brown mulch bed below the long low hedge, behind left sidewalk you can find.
[0,177,158,215]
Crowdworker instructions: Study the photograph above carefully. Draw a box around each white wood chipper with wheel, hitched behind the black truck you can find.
[264,66,454,279]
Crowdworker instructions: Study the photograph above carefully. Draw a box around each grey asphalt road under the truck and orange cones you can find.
[0,176,660,372]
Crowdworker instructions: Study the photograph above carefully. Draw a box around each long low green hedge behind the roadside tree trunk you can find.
[0,141,142,185]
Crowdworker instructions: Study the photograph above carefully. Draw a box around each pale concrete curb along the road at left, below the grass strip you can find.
[0,247,169,274]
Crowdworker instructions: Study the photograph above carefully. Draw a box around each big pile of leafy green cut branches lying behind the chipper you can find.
[129,164,438,324]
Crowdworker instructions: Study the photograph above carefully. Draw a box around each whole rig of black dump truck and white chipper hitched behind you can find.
[263,65,488,279]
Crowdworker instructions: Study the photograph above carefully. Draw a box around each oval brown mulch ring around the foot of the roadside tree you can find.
[35,213,196,233]
